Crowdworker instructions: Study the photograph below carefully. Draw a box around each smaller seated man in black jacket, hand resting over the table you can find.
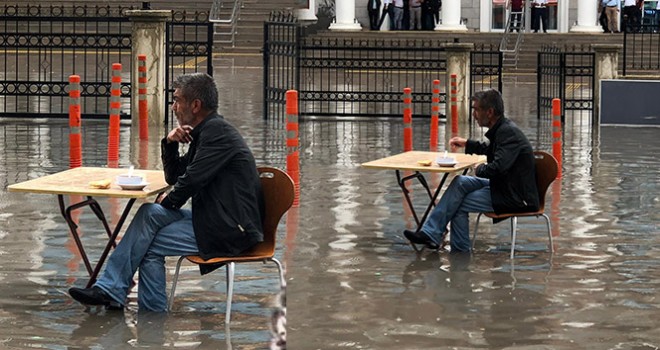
[404,90,539,252]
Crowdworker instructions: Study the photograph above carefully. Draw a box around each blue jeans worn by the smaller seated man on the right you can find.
[421,175,493,252]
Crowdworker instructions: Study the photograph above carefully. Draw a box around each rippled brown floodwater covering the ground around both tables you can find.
[0,60,660,349]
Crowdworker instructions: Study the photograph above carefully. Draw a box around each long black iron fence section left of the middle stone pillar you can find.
[299,37,447,116]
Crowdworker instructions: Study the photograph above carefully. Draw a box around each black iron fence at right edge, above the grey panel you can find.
[623,24,660,75]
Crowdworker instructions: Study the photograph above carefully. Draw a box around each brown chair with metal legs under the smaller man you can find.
[472,151,559,259]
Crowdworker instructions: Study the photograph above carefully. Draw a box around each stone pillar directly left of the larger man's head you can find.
[126,10,172,127]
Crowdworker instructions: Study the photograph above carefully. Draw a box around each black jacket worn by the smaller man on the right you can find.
[465,117,539,214]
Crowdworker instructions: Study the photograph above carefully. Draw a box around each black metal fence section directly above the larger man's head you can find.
[165,10,213,127]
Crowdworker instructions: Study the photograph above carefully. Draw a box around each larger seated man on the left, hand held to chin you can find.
[69,73,263,311]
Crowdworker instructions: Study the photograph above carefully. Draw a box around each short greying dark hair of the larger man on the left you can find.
[172,73,218,112]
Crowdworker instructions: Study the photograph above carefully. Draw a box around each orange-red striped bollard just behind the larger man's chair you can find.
[286,90,300,207]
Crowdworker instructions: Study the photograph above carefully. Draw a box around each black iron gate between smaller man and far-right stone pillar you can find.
[537,46,596,122]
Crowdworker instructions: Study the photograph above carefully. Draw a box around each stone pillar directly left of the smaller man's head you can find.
[443,41,474,141]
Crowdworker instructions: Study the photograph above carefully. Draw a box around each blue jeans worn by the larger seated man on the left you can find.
[95,203,198,312]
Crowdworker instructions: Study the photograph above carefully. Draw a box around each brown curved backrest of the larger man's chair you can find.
[257,167,295,251]
